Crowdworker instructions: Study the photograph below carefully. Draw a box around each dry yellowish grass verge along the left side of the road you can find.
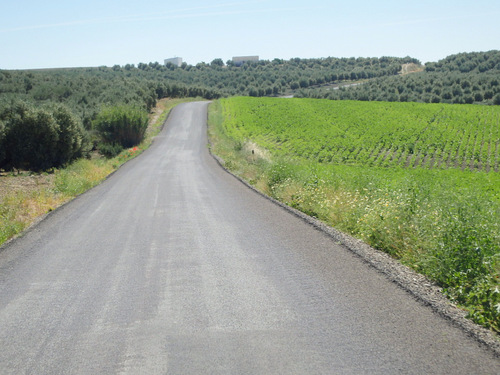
[0,98,201,245]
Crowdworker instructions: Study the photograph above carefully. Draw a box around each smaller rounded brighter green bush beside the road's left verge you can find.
[94,105,148,152]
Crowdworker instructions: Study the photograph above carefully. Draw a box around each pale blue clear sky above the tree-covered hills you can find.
[0,0,500,69]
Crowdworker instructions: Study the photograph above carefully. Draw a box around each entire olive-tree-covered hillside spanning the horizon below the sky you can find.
[0,51,500,129]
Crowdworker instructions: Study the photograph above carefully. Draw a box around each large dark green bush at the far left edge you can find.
[0,103,88,171]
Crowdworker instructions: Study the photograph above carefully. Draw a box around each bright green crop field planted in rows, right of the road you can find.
[222,98,500,172]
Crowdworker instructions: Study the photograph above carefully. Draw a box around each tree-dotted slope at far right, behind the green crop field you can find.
[297,51,500,105]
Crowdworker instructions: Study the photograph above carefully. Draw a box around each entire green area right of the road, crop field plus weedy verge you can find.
[211,97,500,332]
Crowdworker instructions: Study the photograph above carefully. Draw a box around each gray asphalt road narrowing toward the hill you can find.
[0,102,500,374]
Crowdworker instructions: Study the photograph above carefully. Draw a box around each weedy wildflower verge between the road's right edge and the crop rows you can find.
[209,102,500,332]
